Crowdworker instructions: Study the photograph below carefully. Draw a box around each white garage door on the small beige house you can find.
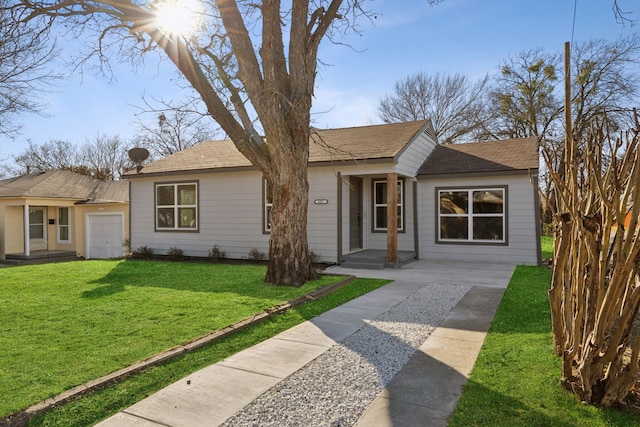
[86,214,124,259]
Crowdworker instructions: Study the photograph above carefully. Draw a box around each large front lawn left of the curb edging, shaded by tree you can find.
[0,260,356,417]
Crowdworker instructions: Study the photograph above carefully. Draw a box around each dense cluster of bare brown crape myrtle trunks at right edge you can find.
[544,111,640,407]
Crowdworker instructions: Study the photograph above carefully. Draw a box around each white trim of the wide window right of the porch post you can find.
[436,187,507,244]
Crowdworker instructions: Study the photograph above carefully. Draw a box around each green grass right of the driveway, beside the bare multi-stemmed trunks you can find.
[449,266,640,427]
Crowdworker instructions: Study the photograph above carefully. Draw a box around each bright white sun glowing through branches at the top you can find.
[156,0,202,37]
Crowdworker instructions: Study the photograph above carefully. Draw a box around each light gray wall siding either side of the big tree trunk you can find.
[130,168,338,262]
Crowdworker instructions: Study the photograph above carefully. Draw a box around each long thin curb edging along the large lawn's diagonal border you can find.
[0,274,356,427]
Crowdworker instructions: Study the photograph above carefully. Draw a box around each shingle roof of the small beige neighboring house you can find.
[0,170,129,204]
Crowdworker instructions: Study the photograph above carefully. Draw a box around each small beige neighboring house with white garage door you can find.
[0,170,129,261]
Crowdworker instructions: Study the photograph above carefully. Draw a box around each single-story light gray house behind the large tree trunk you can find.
[126,121,540,267]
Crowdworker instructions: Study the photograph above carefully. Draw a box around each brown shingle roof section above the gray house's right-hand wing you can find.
[418,137,539,176]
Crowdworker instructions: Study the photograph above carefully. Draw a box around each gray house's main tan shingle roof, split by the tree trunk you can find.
[126,120,427,177]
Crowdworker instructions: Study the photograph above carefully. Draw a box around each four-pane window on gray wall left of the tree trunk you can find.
[156,182,198,231]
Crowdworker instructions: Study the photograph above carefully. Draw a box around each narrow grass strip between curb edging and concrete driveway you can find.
[29,279,389,427]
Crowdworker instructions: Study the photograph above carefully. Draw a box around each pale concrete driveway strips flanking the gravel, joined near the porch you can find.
[98,261,514,427]
